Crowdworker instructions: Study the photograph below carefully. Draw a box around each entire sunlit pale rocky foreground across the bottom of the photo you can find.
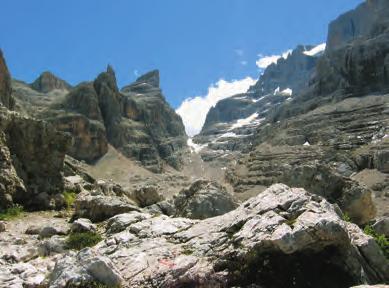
[0,184,389,288]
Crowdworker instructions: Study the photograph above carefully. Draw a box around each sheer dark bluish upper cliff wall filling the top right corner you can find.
[304,0,389,97]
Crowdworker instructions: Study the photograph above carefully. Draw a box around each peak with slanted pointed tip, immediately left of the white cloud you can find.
[116,71,187,170]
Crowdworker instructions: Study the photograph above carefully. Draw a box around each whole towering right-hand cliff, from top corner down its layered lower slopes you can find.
[220,1,389,222]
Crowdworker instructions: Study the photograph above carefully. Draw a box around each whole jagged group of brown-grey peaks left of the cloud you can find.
[13,66,186,172]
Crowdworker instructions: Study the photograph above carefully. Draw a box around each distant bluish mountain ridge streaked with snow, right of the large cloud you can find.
[194,45,322,158]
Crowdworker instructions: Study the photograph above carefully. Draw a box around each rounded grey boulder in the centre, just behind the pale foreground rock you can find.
[173,179,238,219]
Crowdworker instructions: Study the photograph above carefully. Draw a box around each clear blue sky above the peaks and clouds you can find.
[0,0,362,112]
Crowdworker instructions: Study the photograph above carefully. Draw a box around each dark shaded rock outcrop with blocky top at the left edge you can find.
[0,110,70,209]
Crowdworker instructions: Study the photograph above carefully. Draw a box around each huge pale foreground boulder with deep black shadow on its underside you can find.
[49,184,389,288]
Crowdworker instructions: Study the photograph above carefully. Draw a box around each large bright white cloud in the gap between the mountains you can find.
[176,77,256,136]
